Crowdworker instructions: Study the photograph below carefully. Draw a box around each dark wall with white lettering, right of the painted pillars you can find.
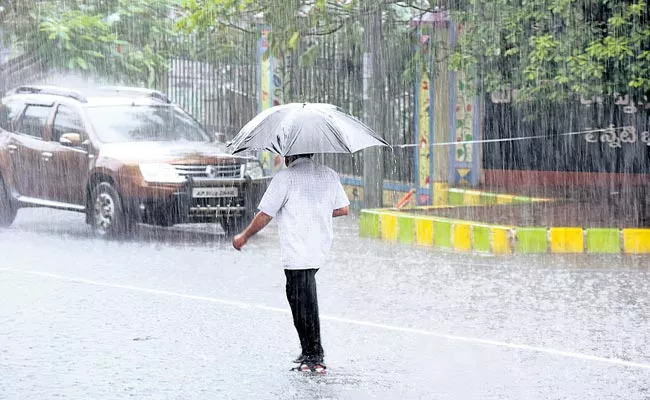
[482,93,650,186]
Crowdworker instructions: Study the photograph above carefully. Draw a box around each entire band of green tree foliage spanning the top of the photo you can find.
[13,0,650,106]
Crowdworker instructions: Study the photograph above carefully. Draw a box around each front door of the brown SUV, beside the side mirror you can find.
[46,104,90,206]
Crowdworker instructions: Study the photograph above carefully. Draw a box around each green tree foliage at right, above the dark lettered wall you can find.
[454,0,650,100]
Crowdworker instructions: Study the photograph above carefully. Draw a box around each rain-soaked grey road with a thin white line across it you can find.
[0,210,650,400]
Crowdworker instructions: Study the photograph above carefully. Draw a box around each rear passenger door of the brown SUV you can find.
[9,104,52,200]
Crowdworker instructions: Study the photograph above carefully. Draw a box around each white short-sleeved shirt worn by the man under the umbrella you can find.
[258,158,350,269]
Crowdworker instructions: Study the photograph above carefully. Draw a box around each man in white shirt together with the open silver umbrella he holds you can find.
[230,104,386,373]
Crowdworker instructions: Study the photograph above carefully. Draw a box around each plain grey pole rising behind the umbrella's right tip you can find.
[362,0,385,208]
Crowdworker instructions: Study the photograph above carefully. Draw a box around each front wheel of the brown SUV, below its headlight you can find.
[89,182,133,238]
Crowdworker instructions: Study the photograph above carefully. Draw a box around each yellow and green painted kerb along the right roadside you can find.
[359,209,650,255]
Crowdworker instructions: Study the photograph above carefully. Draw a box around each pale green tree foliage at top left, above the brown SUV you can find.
[5,0,177,86]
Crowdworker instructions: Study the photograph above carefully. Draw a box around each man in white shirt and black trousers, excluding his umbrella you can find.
[233,155,350,372]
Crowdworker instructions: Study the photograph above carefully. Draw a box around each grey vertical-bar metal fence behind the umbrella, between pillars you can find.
[162,35,414,183]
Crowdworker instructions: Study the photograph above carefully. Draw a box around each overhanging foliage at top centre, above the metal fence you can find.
[179,0,436,62]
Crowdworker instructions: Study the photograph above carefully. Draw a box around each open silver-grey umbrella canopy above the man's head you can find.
[228,103,388,157]
